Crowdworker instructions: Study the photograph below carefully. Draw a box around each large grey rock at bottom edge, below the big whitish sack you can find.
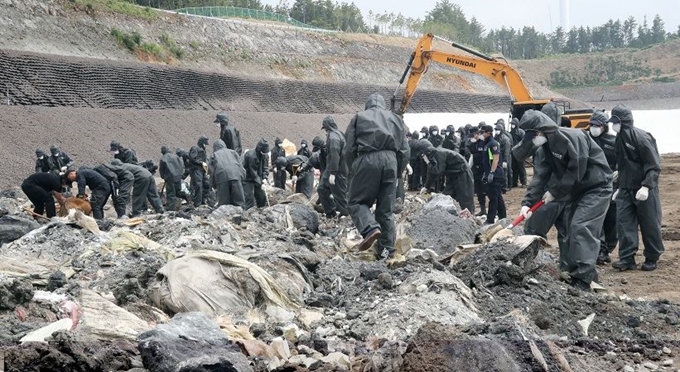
[137,312,253,372]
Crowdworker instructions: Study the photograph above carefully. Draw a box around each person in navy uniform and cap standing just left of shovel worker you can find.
[481,125,506,224]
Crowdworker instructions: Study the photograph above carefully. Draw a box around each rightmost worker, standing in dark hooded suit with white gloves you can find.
[609,105,664,271]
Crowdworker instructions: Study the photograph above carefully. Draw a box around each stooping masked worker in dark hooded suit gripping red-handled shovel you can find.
[513,104,612,291]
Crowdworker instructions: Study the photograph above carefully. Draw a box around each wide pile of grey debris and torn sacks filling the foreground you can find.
[0,193,680,371]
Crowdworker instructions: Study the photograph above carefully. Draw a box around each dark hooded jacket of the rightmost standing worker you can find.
[614,124,661,190]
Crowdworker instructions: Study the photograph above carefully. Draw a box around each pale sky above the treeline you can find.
[262,0,680,33]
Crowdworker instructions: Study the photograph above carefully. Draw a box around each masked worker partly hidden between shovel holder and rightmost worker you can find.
[589,111,619,265]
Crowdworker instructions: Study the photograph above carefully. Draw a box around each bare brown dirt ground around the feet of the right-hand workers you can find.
[505,154,680,303]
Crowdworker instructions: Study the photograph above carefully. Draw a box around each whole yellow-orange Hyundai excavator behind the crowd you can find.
[392,34,594,129]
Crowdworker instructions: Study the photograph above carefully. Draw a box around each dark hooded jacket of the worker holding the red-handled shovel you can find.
[520,110,612,206]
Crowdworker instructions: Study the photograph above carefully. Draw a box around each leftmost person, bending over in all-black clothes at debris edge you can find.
[21,172,64,218]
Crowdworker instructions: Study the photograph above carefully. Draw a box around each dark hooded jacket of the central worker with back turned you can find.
[343,93,409,174]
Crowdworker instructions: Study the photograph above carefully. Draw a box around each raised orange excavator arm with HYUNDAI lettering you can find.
[392,34,533,114]
